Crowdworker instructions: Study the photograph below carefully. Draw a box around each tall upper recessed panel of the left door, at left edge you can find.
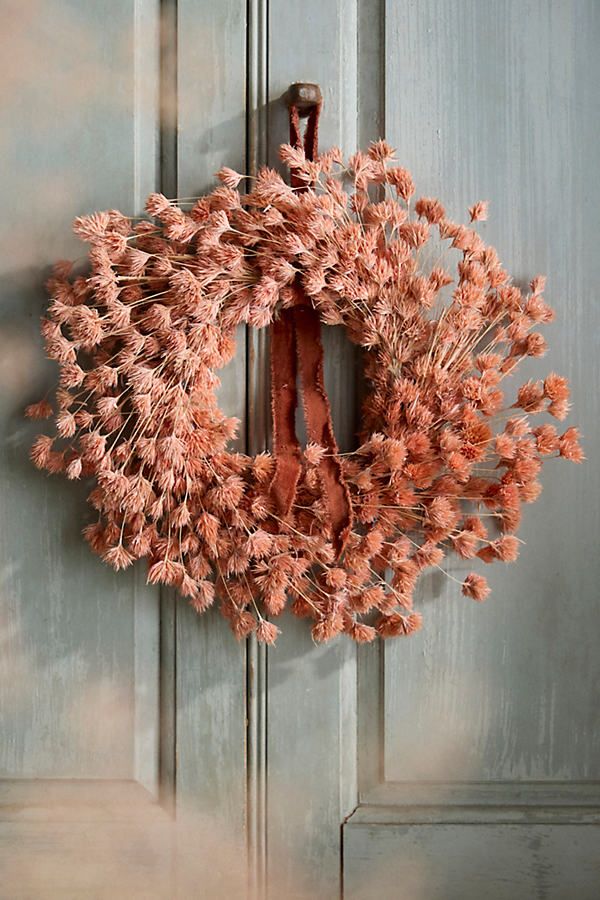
[0,3,158,790]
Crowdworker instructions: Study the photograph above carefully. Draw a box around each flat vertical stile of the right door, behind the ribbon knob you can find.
[266,0,358,900]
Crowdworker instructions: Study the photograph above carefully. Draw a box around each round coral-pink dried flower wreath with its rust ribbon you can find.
[27,102,583,643]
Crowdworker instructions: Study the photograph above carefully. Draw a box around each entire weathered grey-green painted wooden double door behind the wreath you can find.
[0,0,600,900]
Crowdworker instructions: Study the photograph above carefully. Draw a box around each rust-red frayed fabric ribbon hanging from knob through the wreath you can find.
[271,93,352,557]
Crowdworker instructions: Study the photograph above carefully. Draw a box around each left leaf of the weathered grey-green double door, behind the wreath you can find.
[0,0,246,900]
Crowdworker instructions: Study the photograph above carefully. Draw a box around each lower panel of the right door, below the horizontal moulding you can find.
[344,822,600,900]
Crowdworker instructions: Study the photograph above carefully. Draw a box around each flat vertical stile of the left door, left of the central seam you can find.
[175,0,247,900]
